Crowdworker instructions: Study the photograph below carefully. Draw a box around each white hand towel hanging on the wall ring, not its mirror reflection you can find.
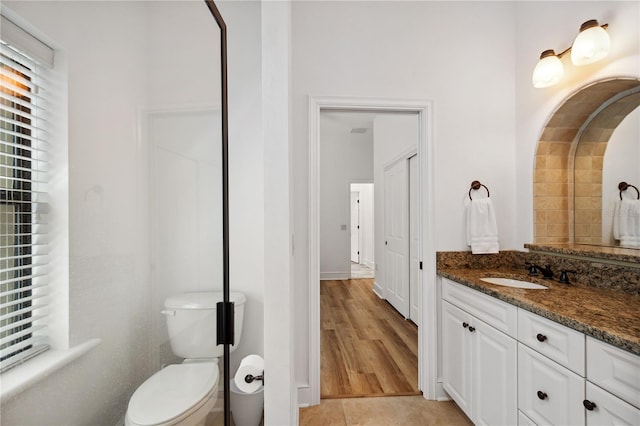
[467,198,498,254]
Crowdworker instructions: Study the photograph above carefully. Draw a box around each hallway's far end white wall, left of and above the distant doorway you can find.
[320,113,373,279]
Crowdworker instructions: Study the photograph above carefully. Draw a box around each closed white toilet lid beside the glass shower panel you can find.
[127,362,218,425]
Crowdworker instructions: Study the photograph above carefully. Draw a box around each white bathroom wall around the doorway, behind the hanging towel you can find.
[292,2,515,390]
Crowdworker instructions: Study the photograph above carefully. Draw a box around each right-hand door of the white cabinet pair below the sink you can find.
[470,319,518,425]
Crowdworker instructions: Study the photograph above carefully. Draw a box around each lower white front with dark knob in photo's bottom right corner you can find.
[585,382,640,426]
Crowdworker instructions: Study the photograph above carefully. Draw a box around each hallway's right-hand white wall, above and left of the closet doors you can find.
[373,113,418,296]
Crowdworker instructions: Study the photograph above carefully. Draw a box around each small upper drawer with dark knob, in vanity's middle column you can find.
[518,309,585,377]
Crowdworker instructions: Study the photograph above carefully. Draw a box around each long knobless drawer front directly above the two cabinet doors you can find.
[442,277,518,338]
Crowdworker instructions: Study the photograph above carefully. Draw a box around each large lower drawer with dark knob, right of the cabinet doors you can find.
[518,343,585,425]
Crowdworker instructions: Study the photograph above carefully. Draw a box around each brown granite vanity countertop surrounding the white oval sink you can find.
[438,268,640,355]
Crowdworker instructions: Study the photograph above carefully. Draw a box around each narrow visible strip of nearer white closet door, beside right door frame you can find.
[409,155,420,324]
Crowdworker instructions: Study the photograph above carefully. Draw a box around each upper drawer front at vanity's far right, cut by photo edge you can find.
[587,337,640,410]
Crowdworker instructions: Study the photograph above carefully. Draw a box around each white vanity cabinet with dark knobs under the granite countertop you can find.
[442,277,640,426]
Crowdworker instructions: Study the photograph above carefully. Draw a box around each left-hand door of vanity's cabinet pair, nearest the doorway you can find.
[442,301,472,417]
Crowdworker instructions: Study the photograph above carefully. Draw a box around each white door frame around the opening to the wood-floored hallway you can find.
[308,96,441,405]
